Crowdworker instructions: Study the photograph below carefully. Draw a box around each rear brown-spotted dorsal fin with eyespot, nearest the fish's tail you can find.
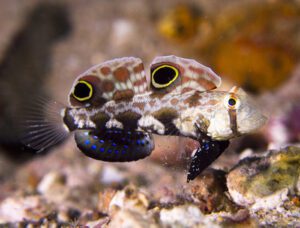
[69,57,148,106]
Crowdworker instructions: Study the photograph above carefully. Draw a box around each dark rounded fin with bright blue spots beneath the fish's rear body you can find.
[75,129,154,162]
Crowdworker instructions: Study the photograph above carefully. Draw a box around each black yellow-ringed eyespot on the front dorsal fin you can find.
[151,64,179,89]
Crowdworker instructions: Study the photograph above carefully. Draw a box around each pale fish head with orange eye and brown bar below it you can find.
[207,87,267,140]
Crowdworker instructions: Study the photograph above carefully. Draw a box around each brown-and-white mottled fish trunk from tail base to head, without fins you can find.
[65,90,259,140]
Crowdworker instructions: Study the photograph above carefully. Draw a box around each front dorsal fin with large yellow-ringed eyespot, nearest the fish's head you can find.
[150,55,221,93]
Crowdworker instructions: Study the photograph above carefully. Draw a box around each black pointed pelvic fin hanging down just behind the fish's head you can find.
[187,140,229,182]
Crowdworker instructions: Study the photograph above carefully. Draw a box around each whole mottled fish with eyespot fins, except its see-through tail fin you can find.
[23,56,265,180]
